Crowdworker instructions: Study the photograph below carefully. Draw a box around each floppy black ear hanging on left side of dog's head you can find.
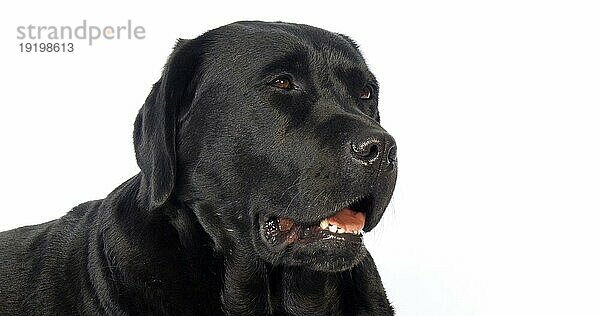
[133,39,200,210]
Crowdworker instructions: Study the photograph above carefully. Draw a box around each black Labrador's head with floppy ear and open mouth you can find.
[134,22,396,271]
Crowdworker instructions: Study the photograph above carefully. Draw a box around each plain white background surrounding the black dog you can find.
[0,0,600,316]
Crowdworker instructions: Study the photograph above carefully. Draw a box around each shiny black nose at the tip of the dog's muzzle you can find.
[350,133,396,170]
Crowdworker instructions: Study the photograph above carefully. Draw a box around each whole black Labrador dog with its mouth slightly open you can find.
[0,22,396,315]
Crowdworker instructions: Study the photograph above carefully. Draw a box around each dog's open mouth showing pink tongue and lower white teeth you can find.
[261,197,371,247]
